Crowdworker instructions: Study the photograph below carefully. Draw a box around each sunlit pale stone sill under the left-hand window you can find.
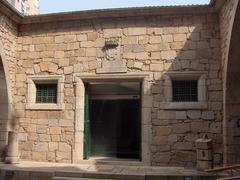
[26,103,65,111]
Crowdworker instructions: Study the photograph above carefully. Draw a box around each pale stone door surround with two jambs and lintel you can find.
[72,73,152,165]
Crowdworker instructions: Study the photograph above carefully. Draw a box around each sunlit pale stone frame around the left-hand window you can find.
[26,75,65,110]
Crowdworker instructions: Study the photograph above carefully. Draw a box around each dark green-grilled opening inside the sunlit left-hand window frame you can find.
[36,84,57,103]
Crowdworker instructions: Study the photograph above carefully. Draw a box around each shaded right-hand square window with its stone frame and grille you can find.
[160,71,208,110]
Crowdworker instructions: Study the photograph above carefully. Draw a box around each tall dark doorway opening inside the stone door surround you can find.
[84,82,141,160]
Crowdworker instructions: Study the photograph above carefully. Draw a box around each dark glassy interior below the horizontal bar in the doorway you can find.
[89,100,140,159]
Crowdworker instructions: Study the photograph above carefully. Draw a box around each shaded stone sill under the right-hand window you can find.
[160,102,207,110]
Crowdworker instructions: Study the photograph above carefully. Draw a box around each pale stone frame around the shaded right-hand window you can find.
[160,71,207,110]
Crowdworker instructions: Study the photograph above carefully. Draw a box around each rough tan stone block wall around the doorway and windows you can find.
[0,1,238,167]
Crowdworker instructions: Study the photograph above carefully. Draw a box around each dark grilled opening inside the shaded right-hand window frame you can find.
[172,80,198,102]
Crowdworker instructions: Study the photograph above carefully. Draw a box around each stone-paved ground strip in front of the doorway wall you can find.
[0,161,218,179]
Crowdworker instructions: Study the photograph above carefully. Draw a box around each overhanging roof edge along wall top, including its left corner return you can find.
[0,0,224,24]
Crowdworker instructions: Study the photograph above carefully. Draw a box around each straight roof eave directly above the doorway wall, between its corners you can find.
[22,5,215,24]
